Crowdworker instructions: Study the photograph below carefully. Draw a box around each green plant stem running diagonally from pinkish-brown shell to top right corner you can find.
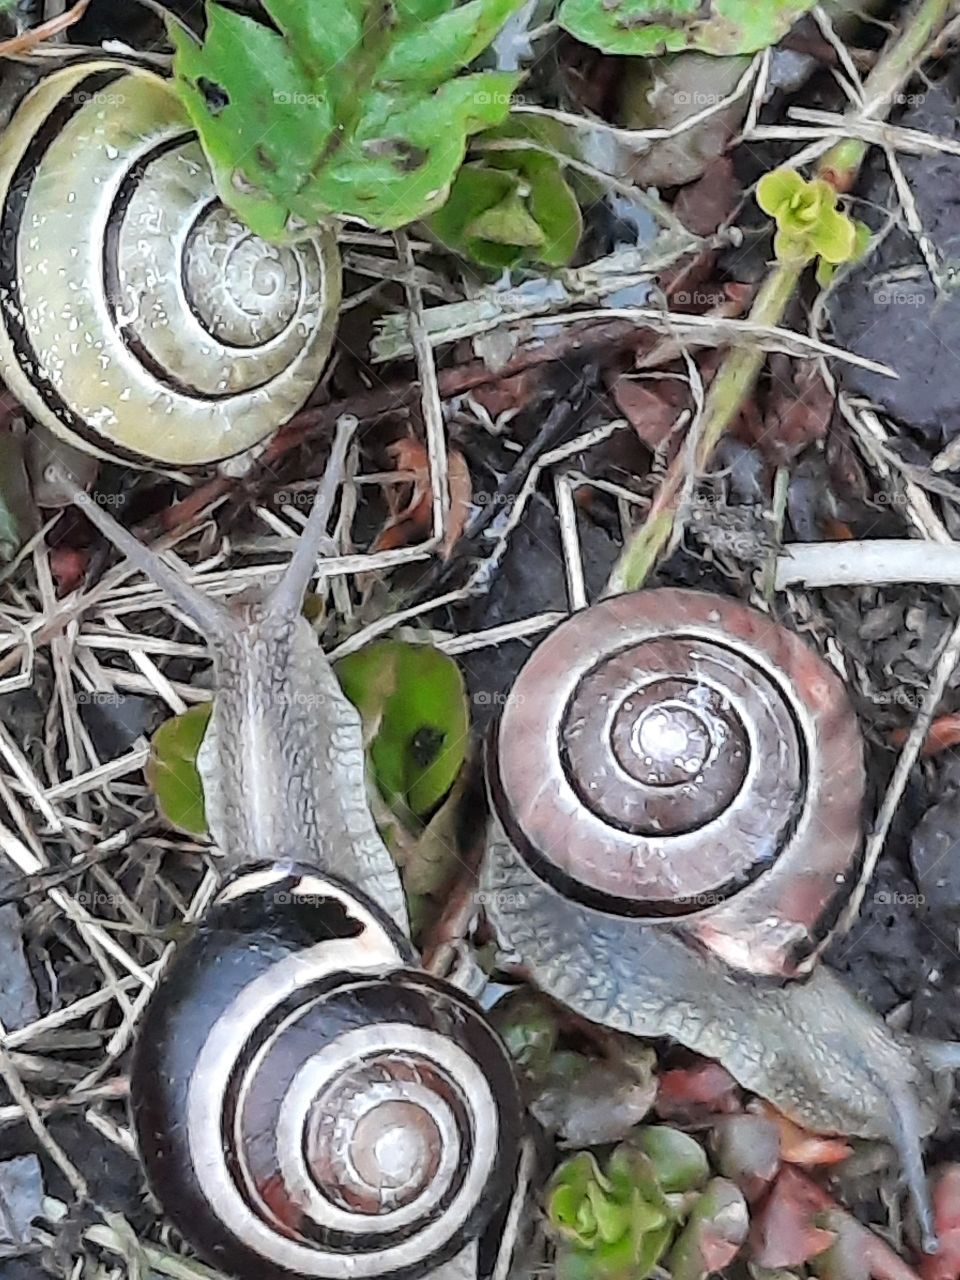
[607,0,955,594]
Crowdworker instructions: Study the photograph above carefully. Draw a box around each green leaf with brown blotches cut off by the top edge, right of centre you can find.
[558,0,815,58]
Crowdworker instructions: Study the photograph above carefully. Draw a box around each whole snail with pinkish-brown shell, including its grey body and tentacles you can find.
[481,589,960,1251]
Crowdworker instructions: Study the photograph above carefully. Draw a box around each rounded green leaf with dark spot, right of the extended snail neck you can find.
[337,640,470,819]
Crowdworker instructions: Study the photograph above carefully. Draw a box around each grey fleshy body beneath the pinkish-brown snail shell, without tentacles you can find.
[483,832,934,1146]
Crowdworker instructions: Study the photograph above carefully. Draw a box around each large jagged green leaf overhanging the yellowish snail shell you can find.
[170,0,535,241]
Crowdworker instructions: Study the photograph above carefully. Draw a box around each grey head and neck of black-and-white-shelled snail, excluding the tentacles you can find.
[197,603,407,928]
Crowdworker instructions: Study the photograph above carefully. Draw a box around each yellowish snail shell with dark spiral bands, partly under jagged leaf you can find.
[0,60,340,467]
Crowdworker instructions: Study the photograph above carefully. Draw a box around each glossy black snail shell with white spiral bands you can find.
[131,864,521,1280]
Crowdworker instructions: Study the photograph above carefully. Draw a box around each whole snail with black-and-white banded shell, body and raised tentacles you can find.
[49,419,524,1280]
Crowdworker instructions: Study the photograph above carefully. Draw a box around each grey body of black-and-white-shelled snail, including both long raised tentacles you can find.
[51,419,407,931]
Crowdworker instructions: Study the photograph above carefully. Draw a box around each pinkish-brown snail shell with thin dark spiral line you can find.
[488,589,864,977]
